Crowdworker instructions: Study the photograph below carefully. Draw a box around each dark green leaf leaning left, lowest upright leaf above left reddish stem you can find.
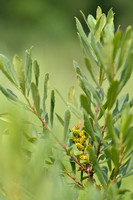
[31,82,40,114]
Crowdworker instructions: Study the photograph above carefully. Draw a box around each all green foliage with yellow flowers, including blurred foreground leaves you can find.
[0,7,133,200]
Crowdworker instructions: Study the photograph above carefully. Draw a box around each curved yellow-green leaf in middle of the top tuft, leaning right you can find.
[94,14,106,42]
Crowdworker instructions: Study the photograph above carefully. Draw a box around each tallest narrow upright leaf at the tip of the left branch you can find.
[25,47,33,96]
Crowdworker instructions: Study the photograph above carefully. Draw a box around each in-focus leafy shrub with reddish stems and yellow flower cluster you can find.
[0,7,133,200]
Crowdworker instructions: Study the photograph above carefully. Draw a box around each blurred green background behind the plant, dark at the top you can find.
[0,0,133,195]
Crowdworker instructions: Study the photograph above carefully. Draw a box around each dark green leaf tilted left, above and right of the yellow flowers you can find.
[80,94,94,119]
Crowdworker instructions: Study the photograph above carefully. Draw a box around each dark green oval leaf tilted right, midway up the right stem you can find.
[107,81,119,110]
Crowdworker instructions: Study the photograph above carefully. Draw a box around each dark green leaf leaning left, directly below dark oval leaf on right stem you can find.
[106,113,118,146]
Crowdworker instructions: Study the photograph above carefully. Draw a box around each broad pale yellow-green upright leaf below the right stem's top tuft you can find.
[103,39,114,82]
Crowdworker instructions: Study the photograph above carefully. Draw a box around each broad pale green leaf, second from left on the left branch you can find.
[13,55,25,95]
